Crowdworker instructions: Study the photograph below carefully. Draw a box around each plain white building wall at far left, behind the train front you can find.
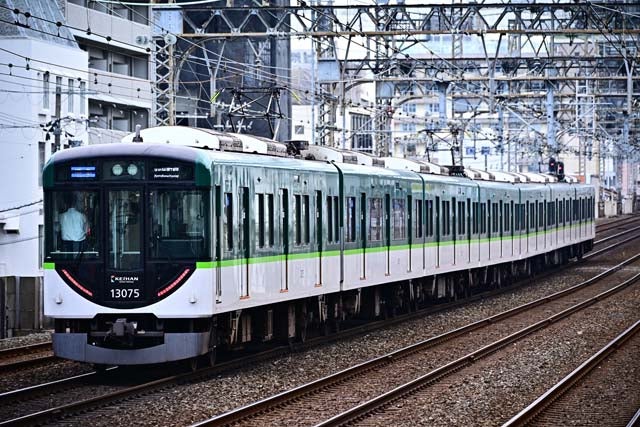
[0,38,88,277]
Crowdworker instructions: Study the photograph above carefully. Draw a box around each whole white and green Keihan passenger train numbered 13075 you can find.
[43,127,595,365]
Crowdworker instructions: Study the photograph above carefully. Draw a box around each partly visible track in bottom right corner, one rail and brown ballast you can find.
[504,320,640,427]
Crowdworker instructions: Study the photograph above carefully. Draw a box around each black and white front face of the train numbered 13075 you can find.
[44,144,214,365]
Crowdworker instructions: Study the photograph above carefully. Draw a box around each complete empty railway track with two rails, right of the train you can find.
[192,254,640,426]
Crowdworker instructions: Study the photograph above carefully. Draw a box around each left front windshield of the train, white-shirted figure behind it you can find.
[47,191,101,259]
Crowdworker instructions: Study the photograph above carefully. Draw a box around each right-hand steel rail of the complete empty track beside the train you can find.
[316,273,640,427]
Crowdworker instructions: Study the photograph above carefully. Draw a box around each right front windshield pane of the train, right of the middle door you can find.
[149,189,210,259]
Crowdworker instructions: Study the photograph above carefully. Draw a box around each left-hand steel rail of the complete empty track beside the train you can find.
[194,253,640,426]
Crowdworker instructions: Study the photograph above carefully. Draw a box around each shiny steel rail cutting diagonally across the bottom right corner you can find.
[503,320,640,427]
